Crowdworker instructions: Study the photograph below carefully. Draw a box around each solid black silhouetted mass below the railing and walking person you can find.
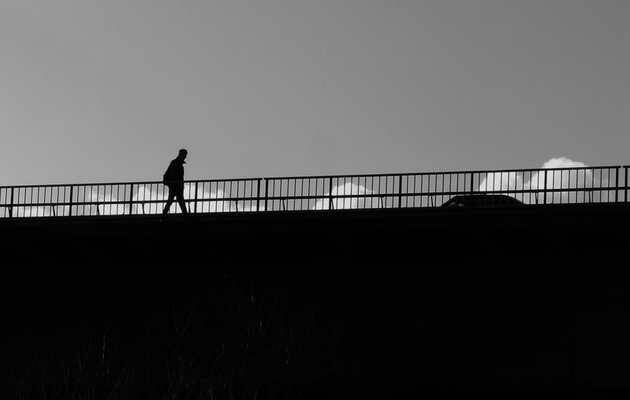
[0,205,630,400]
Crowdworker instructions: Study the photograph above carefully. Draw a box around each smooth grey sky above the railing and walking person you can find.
[0,0,630,185]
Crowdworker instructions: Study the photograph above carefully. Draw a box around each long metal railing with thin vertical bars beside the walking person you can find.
[0,166,630,218]
